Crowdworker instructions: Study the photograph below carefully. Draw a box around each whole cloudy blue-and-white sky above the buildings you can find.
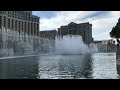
[33,11,120,40]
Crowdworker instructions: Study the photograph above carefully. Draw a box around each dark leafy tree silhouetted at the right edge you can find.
[110,18,120,51]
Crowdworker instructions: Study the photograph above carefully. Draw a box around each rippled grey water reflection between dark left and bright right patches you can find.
[38,54,93,79]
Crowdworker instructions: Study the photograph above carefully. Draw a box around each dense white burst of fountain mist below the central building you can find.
[55,35,98,54]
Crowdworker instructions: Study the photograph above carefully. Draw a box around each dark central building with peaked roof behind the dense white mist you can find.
[58,22,93,44]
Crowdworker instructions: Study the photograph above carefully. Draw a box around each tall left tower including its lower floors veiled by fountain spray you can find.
[0,11,40,57]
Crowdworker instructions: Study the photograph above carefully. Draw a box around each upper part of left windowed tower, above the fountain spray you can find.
[0,11,39,36]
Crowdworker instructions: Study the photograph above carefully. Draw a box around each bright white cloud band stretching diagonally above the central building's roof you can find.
[37,11,98,31]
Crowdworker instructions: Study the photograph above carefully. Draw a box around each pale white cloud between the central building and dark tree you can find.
[91,14,119,40]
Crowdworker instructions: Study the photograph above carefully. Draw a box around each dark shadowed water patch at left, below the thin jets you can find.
[0,57,38,79]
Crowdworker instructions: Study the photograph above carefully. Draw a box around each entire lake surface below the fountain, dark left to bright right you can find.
[0,53,119,79]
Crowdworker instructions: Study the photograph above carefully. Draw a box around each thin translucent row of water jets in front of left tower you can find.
[0,28,51,57]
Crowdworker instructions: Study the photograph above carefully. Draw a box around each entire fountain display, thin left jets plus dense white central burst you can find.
[0,28,98,57]
